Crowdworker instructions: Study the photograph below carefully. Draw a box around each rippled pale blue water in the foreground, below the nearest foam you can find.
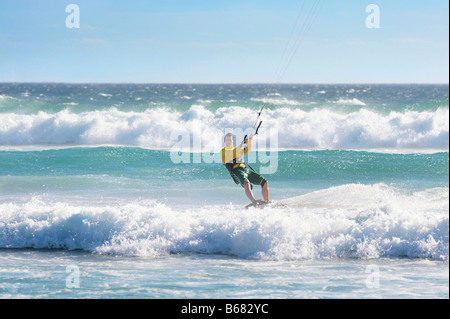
[0,250,449,300]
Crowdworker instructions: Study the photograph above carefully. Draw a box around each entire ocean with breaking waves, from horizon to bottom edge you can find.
[0,83,449,298]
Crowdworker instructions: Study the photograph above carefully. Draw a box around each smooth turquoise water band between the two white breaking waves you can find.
[0,147,449,206]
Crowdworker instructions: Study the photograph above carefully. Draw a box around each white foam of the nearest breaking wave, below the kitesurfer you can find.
[0,184,449,260]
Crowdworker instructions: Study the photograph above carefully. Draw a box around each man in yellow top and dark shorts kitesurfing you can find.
[221,133,269,205]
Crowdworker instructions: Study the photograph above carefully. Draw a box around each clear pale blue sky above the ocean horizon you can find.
[0,0,449,83]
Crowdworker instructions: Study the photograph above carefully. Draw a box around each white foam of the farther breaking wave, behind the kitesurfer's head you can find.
[0,104,449,152]
